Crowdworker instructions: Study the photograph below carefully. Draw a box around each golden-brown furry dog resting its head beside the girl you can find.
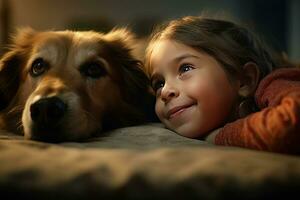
[0,28,154,142]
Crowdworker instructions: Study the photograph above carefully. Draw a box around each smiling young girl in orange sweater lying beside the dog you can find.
[145,16,300,154]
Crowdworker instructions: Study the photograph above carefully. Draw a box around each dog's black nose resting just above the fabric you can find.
[30,97,67,129]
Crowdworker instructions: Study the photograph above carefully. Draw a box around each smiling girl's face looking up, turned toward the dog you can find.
[150,40,239,138]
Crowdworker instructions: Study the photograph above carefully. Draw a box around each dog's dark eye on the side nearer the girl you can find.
[80,62,106,79]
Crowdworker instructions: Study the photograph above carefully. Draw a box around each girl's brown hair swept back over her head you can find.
[145,16,286,79]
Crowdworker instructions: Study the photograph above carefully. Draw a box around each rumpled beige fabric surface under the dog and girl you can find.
[0,124,300,200]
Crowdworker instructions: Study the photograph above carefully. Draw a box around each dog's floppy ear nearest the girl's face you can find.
[105,28,157,121]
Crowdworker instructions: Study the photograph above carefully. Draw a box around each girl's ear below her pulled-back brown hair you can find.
[238,62,260,98]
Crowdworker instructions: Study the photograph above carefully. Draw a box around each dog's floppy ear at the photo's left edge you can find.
[0,28,34,110]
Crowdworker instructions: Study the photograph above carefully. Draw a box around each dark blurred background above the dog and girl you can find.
[0,0,300,61]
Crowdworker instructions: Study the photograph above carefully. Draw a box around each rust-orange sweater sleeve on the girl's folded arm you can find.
[215,68,300,154]
